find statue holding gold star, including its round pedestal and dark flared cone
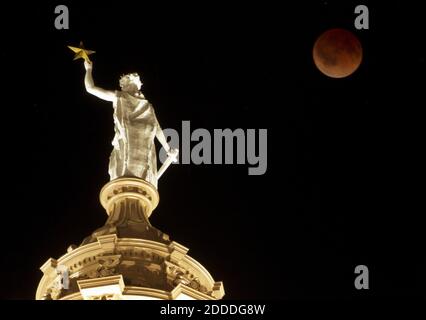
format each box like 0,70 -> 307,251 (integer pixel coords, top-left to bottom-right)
68,43 -> 179,245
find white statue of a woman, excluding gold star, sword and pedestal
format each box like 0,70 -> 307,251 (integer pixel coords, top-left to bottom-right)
84,60 -> 178,187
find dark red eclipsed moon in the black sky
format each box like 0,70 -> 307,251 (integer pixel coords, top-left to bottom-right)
313,29 -> 362,78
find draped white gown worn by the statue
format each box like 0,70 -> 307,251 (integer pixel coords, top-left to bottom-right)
109,91 -> 159,187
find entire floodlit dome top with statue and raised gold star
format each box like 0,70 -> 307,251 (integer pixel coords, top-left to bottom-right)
36,52 -> 224,300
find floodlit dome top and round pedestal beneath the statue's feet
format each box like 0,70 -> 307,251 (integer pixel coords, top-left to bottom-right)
36,178 -> 224,300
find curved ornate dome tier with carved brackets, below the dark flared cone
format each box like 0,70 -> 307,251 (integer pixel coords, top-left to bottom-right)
37,235 -> 224,299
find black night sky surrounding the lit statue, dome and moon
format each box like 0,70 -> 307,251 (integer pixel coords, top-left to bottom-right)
0,1 -> 426,299
